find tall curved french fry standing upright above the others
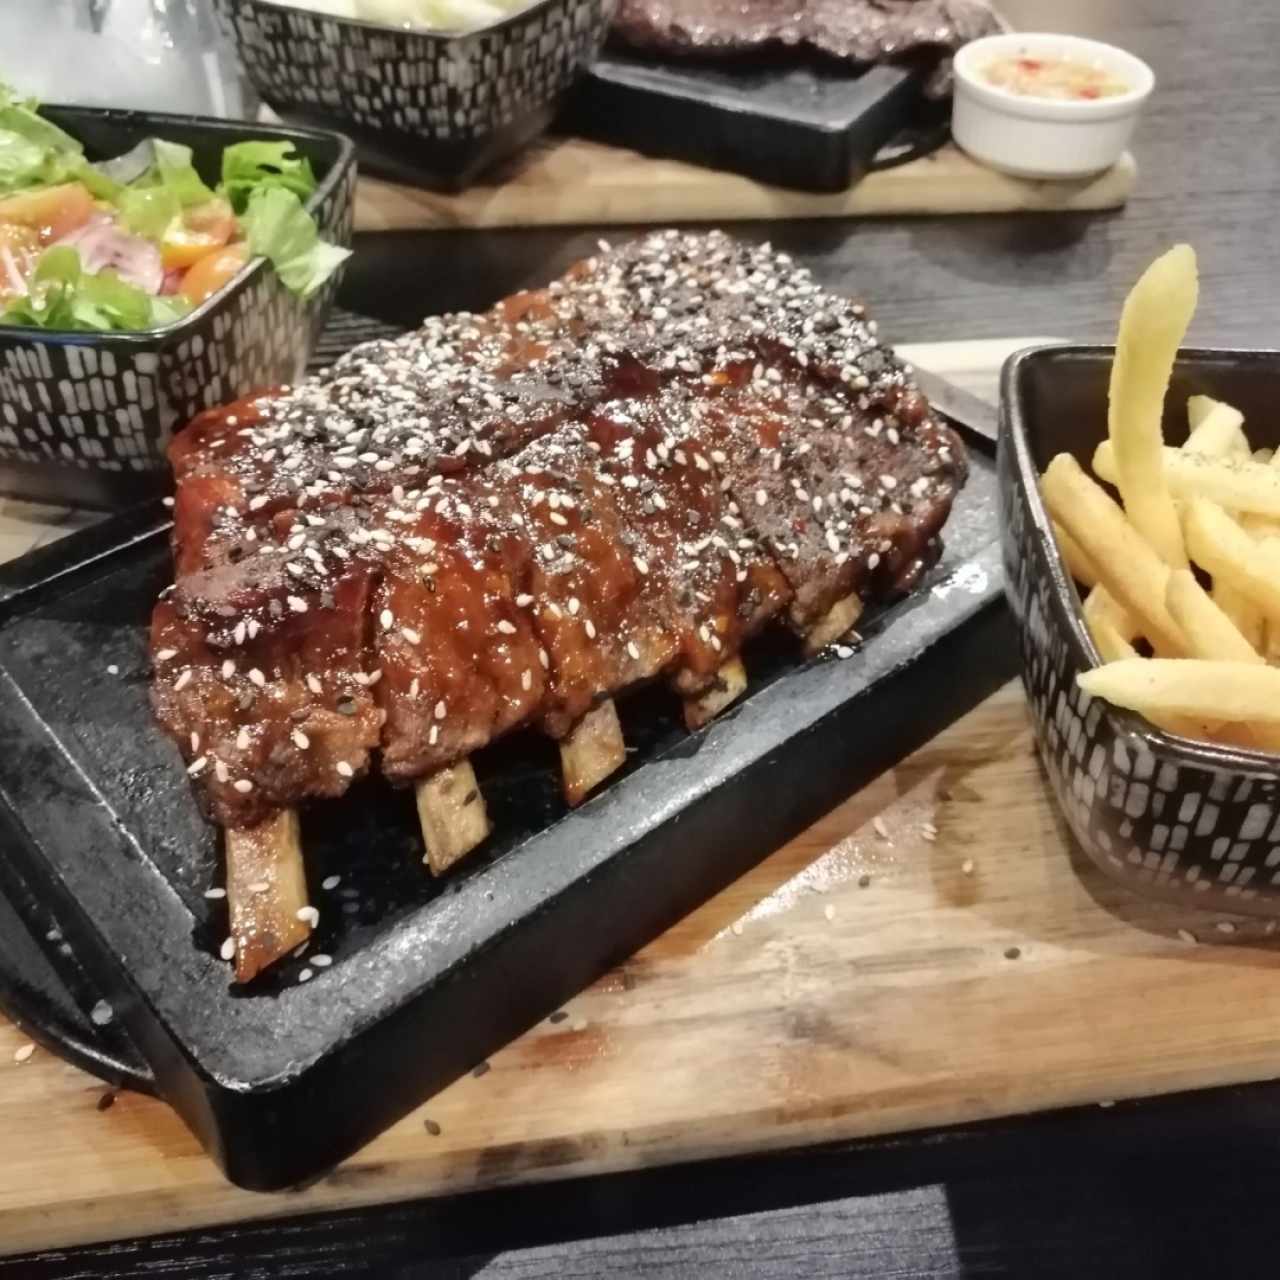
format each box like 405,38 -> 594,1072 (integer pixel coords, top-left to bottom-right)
1107,244 -> 1198,568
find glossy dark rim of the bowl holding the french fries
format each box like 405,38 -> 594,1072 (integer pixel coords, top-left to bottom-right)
1000,343 -> 1280,777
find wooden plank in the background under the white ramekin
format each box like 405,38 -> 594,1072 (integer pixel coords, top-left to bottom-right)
356,138 -> 1138,232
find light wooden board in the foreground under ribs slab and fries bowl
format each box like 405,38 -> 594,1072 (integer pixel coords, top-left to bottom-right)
10,343 -> 1280,1253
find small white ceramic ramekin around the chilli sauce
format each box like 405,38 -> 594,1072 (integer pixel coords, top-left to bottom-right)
951,32 -> 1156,178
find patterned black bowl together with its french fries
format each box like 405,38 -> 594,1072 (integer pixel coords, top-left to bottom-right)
1000,246 -> 1280,932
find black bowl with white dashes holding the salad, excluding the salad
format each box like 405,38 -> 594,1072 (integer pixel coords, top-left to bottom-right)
0,106 -> 356,507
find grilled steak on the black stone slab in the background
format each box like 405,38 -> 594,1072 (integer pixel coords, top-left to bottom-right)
613,0 -> 1001,63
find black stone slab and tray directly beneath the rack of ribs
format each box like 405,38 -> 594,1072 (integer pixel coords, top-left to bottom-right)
0,327 -> 1014,1189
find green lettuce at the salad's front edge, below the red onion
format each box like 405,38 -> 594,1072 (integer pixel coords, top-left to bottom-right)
0,244 -> 189,332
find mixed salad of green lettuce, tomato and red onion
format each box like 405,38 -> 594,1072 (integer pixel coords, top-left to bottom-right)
0,84 -> 349,330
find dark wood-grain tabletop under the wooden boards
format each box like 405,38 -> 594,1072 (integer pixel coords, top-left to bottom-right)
12,0 -> 1280,1280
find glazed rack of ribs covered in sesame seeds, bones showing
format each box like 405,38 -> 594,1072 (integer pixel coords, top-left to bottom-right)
152,232 -> 966,980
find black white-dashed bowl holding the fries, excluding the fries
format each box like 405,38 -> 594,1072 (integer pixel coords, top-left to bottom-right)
998,346 -> 1280,933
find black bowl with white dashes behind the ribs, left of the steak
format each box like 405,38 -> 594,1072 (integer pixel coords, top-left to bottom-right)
218,0 -> 617,189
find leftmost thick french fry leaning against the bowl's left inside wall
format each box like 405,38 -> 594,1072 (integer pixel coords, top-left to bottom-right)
1041,453 -> 1184,657
